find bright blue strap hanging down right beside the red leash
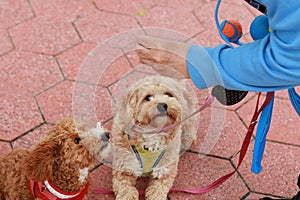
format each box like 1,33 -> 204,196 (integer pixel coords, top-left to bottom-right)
251,92 -> 274,174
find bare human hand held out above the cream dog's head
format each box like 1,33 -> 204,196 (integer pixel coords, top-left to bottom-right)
137,36 -> 191,78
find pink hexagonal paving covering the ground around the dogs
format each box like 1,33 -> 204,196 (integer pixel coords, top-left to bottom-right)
0,0 -> 300,200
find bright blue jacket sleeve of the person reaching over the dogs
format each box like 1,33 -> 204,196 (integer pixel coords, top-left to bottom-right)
187,0 -> 300,91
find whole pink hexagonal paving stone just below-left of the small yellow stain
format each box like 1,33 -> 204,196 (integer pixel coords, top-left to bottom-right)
75,12 -> 139,42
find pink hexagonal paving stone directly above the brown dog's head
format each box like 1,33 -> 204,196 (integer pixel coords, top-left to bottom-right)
37,81 -> 112,126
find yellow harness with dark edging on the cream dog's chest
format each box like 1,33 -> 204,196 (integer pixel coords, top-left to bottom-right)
131,145 -> 165,174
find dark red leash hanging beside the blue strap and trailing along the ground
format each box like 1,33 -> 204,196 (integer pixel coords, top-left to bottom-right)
93,92 -> 274,195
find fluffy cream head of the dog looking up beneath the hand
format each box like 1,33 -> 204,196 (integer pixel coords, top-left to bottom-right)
116,76 -> 195,142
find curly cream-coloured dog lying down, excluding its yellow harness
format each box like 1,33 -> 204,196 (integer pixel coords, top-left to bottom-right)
112,76 -> 197,200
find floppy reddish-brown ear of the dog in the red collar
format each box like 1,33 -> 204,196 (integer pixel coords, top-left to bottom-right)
23,138 -> 58,181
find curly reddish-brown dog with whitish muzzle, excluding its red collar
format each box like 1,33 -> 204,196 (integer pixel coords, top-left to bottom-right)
0,118 -> 110,200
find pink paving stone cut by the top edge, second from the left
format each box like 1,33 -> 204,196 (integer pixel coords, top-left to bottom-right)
31,0 -> 97,22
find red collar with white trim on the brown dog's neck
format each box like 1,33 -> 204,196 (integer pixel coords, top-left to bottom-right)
29,180 -> 89,200
